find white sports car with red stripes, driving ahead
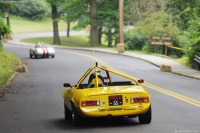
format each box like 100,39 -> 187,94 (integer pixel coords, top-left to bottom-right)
29,42 -> 55,58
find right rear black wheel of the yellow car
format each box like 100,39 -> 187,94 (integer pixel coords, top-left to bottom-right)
138,106 -> 151,124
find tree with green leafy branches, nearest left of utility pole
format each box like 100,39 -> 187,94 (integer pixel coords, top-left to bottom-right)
61,0 -> 98,47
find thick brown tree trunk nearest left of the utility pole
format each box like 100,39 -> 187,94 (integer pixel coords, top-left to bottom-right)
90,0 -> 99,47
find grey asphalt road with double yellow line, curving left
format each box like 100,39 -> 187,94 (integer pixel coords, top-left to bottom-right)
0,44 -> 200,133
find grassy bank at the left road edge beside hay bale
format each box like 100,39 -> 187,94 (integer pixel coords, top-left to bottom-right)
0,50 -> 19,88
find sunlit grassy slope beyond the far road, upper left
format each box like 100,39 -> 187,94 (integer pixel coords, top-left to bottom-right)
10,16 -> 75,34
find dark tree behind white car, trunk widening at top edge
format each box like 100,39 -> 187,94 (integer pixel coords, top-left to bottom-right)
47,0 -> 62,44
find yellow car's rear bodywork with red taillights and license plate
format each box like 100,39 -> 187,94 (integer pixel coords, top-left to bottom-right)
76,86 -> 151,123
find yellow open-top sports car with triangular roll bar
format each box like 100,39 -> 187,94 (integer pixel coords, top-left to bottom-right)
62,63 -> 151,125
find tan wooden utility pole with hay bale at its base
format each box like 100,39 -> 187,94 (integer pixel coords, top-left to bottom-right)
117,0 -> 125,53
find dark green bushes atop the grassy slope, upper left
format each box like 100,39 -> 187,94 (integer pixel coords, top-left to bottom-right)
11,0 -> 50,20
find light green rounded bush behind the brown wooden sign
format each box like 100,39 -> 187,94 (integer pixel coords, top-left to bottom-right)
138,11 -> 180,55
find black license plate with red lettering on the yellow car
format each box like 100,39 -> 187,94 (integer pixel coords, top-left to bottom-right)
108,95 -> 123,106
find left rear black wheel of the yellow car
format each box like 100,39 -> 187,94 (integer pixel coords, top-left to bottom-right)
72,105 -> 81,126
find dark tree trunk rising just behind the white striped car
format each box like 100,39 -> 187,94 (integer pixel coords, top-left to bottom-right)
51,3 -> 60,44
